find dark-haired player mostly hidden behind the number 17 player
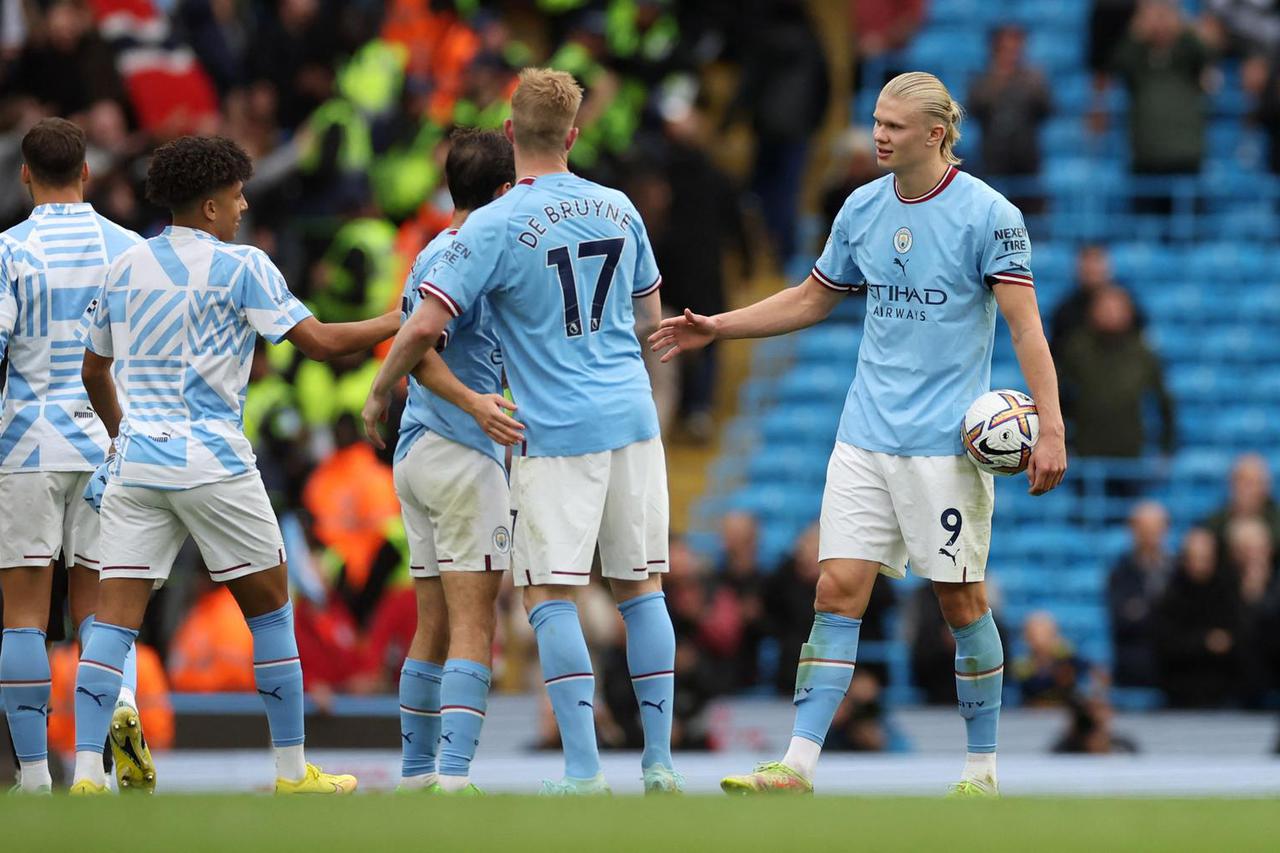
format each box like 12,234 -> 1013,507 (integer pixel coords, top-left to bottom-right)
370,131 -> 524,794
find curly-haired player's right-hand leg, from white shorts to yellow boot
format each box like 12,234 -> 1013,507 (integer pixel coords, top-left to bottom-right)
177,471 -> 356,794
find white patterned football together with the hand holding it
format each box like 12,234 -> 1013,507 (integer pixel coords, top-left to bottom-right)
960,389 -> 1066,494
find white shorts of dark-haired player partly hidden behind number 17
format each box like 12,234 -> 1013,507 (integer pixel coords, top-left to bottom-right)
396,433 -> 511,578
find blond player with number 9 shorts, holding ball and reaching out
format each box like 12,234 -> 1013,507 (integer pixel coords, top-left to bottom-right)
650,72 -> 1066,795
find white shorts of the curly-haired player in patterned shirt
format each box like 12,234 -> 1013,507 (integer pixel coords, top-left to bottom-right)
101,470 -> 284,587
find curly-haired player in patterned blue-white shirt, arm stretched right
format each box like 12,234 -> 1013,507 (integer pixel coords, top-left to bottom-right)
72,136 -> 399,794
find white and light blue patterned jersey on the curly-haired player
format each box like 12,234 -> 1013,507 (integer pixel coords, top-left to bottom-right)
78,227 -> 311,489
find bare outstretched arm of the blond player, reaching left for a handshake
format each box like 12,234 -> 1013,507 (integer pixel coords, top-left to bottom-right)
649,275 -> 847,361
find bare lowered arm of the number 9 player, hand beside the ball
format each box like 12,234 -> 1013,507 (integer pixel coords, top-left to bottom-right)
995,283 -> 1066,494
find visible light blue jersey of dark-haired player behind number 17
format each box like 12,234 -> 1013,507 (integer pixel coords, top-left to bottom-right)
396,228 -> 504,465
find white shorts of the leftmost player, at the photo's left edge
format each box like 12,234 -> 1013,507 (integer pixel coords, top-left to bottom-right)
0,471 -> 99,571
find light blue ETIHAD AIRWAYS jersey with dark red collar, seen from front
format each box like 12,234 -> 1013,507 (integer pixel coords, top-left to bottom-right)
813,167 -> 1033,456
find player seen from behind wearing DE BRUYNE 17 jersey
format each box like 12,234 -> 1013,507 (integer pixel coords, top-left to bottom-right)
365,68 -> 682,794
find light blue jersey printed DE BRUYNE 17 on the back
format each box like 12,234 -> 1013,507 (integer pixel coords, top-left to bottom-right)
422,172 -> 662,456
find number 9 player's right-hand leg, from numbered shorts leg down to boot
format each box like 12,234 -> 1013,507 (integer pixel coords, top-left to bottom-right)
884,456 -> 1005,795
